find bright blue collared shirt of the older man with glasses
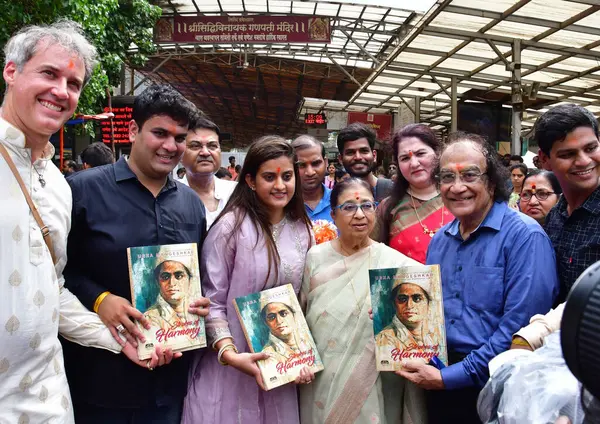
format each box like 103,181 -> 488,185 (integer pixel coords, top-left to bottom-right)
427,202 -> 558,389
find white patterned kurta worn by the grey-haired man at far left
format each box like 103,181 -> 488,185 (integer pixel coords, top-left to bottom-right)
0,119 -> 121,424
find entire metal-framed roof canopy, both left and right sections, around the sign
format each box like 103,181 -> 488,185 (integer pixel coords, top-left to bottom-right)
135,0 -> 600,144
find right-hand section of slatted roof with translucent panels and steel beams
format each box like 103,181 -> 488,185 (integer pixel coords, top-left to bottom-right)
343,0 -> 600,132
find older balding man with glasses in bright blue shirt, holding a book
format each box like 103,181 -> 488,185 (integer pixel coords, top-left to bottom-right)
399,133 -> 558,424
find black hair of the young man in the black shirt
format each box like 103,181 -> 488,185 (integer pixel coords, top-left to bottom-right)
132,84 -> 198,129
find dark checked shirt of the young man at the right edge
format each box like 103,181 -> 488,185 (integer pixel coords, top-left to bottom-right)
544,187 -> 600,302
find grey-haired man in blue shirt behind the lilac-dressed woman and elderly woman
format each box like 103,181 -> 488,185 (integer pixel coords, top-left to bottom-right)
292,135 -> 333,222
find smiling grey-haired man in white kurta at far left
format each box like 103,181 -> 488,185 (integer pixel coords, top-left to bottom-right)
0,22 -> 126,424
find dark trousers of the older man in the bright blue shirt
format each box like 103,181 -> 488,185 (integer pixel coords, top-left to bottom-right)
427,387 -> 481,424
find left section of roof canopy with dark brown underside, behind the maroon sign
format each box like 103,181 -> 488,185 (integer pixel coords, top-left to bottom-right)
131,0 -> 422,143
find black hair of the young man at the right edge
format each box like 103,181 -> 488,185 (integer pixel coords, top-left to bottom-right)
534,103 -> 598,157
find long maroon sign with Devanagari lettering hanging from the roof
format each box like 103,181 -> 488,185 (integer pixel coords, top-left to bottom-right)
154,15 -> 331,44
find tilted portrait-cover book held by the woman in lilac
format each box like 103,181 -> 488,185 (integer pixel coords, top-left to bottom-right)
233,284 -> 323,390
